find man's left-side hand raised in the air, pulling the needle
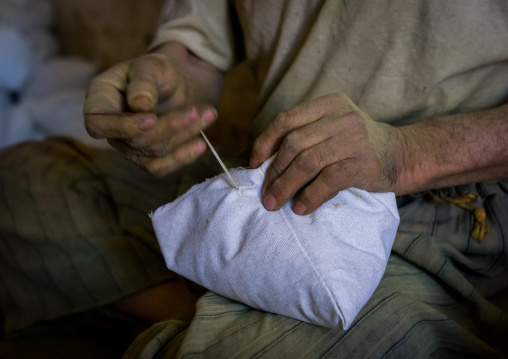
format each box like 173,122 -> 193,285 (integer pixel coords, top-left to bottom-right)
84,43 -> 223,176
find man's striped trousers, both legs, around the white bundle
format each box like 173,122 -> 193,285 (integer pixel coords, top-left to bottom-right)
0,139 -> 508,359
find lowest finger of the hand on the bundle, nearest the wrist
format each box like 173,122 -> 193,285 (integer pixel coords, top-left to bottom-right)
293,159 -> 360,215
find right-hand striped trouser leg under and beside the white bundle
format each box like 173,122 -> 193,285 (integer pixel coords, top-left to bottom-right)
125,185 -> 508,358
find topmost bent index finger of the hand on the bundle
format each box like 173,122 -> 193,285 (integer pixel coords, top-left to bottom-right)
250,101 -> 323,168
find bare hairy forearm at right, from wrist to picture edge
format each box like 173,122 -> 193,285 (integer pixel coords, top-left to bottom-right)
396,105 -> 508,195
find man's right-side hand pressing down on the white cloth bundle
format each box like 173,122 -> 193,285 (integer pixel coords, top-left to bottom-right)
250,94 -> 404,215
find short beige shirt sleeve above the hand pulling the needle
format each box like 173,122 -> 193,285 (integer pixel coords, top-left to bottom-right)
150,0 -> 236,71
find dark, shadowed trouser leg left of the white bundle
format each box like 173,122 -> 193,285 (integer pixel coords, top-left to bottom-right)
0,138 -> 189,332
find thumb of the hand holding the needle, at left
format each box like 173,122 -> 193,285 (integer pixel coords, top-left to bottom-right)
127,54 -> 177,112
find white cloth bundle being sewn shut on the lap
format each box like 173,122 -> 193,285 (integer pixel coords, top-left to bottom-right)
152,160 -> 399,329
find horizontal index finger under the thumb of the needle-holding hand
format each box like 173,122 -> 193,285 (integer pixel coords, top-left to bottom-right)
84,113 -> 157,139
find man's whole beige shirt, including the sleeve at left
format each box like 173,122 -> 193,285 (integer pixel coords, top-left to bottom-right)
154,0 -> 508,134
